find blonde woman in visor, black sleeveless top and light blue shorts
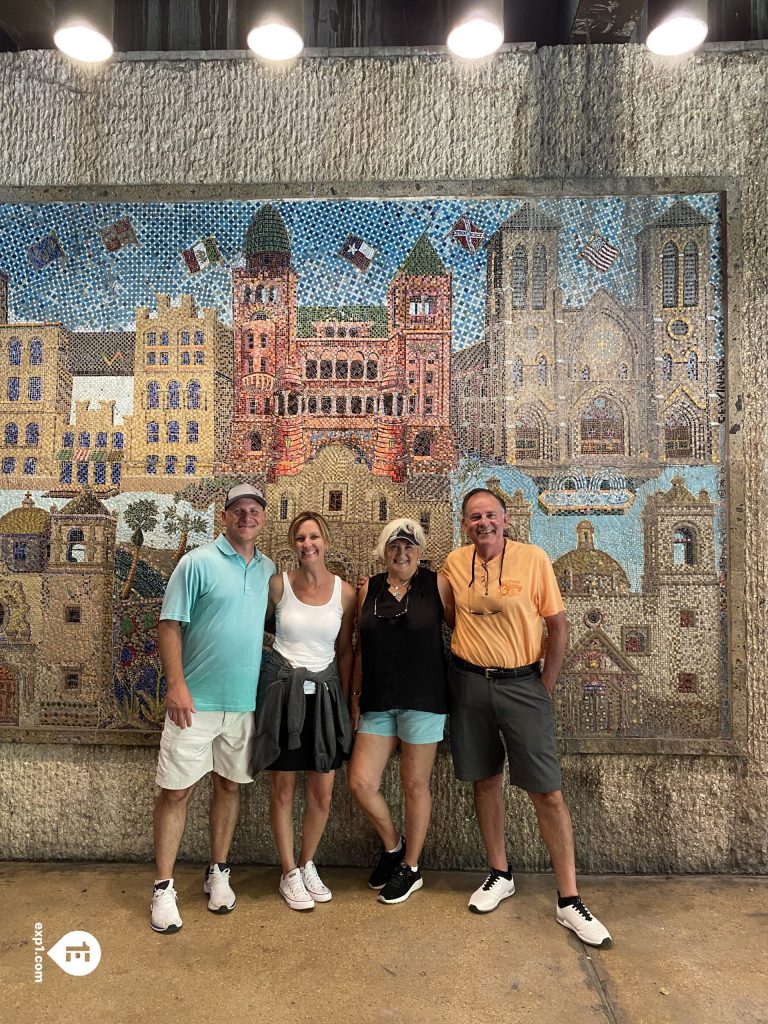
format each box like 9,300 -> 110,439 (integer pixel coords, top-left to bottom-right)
349,519 -> 453,903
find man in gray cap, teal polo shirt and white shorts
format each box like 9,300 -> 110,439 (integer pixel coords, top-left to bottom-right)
152,483 -> 275,933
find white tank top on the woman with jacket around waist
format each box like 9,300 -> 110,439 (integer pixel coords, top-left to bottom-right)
274,572 -> 343,693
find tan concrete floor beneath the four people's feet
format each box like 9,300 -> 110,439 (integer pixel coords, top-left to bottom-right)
0,862 -> 768,1024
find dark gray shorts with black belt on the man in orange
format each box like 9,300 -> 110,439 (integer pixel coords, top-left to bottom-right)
449,665 -> 562,793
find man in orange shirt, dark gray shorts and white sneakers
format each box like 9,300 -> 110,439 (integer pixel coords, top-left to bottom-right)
442,487 -> 610,946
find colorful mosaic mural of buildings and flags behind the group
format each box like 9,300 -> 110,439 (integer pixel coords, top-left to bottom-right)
0,194 -> 730,739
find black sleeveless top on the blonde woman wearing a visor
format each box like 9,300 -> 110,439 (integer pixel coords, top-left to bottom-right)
359,568 -> 447,714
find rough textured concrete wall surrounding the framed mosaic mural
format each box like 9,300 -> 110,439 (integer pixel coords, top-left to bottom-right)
0,46 -> 768,871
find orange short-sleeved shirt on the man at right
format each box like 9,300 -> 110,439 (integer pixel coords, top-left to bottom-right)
442,541 -> 564,669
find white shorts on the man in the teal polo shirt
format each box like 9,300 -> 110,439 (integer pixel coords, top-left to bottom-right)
155,711 -> 255,790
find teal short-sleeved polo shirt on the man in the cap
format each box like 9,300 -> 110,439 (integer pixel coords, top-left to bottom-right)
160,534 -> 275,711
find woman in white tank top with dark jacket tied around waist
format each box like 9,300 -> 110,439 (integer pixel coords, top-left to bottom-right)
256,512 -> 355,910
